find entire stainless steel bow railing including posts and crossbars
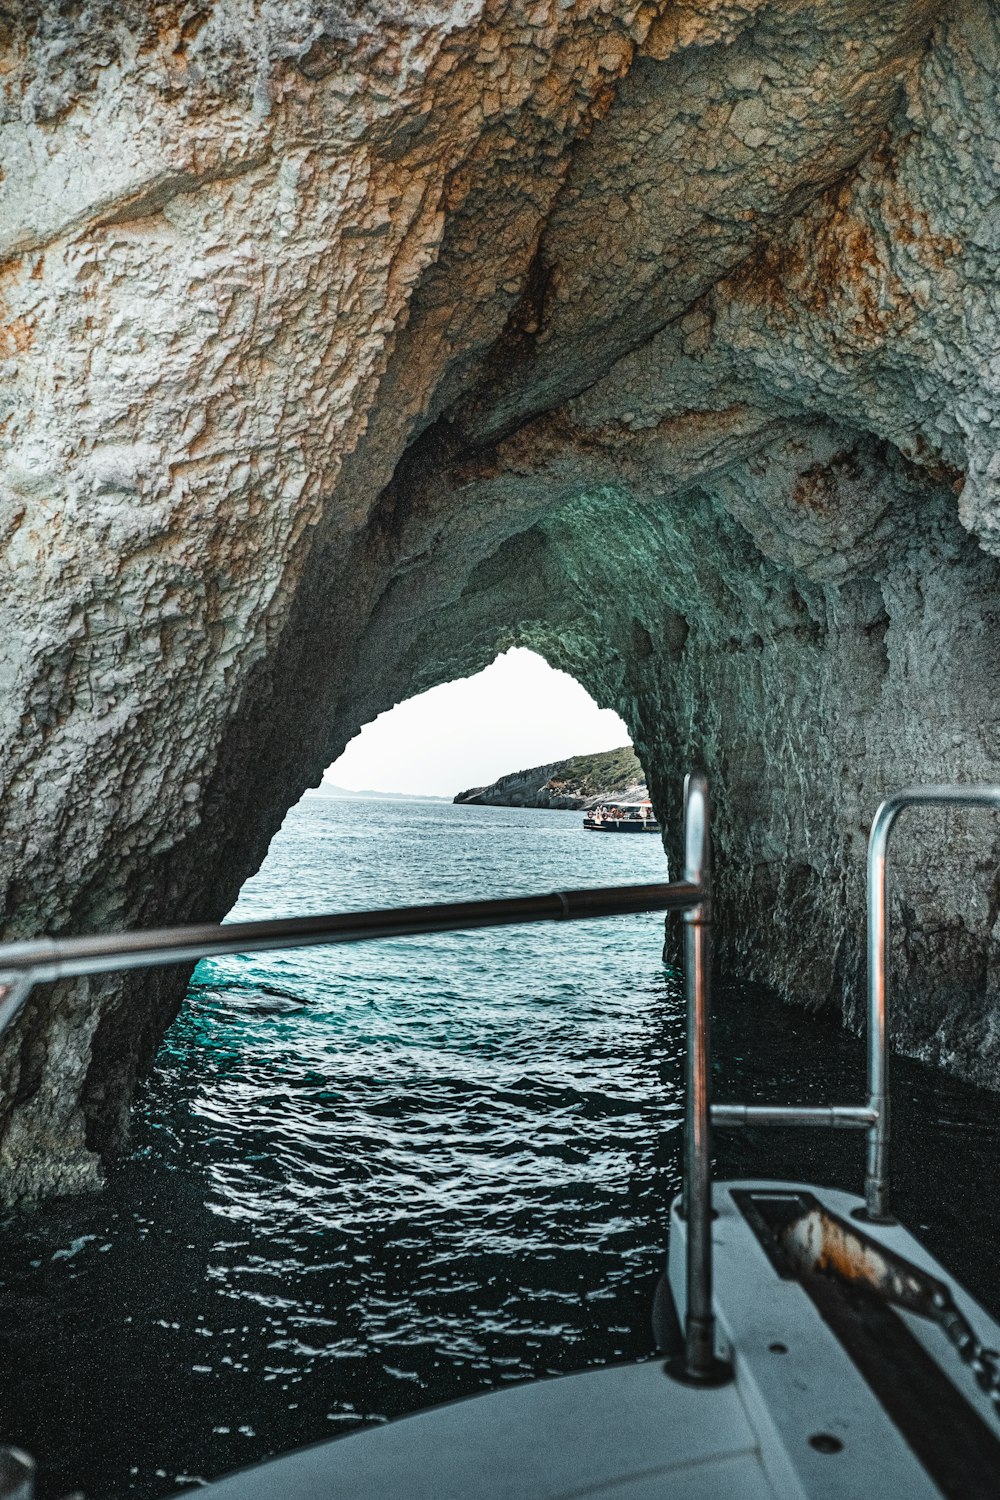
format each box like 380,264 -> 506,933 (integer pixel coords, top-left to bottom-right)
0,776 -> 1000,1385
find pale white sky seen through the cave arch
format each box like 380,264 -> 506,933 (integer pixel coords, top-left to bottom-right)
324,647 -> 628,797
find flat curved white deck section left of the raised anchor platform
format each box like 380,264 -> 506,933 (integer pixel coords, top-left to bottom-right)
201,1361 -> 775,1500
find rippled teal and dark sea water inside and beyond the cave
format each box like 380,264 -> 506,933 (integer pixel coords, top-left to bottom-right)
0,798 -> 1000,1500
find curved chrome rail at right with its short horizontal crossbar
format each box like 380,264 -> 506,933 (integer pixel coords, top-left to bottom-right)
711,786 -> 1000,1223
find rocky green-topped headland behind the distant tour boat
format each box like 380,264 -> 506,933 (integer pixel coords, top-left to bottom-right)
454,746 -> 649,809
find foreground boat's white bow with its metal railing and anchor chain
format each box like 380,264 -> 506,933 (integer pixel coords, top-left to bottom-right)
0,777 -> 1000,1500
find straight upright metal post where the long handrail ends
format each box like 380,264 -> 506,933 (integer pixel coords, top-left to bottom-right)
667,776 -> 732,1385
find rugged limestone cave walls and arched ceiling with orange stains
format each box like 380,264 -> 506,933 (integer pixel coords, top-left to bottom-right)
0,0 -> 1000,1196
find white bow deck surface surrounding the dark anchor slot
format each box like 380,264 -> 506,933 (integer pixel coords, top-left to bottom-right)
202,1182 -> 1000,1500
